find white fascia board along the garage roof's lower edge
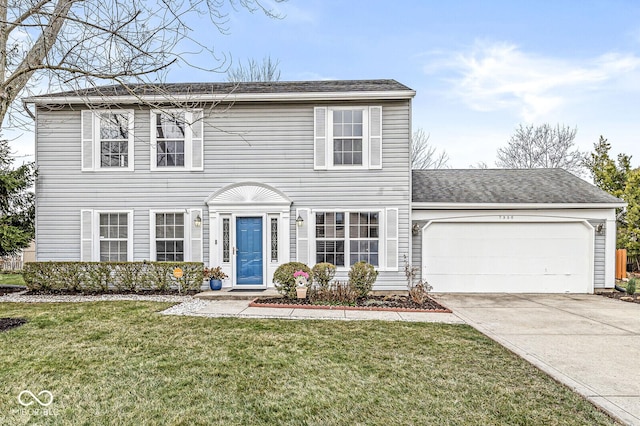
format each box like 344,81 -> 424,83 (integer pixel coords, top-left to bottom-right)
411,202 -> 627,210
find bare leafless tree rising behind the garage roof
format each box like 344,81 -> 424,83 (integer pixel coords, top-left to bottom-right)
496,124 -> 586,176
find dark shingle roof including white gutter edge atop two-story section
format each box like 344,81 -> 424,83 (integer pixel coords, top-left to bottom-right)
25,80 -> 415,103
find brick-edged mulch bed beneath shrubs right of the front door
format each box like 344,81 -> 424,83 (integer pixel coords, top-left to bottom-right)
249,295 -> 451,313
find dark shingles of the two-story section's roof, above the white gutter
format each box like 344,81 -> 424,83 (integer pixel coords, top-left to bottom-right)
33,80 -> 412,99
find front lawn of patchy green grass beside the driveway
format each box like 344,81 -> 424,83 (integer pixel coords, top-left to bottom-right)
0,302 -> 613,426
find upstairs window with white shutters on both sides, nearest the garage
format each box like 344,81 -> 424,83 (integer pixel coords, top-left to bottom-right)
314,106 -> 382,170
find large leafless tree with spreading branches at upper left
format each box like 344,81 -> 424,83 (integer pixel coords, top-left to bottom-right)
0,0 -> 283,130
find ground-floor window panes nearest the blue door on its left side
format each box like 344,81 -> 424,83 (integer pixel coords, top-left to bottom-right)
155,213 -> 185,262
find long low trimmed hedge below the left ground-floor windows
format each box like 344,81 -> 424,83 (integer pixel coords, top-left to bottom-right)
23,262 -> 204,293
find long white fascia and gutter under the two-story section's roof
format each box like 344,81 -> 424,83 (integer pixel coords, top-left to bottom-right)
24,90 -> 416,105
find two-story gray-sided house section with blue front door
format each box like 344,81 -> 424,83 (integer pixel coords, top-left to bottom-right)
27,80 -> 415,289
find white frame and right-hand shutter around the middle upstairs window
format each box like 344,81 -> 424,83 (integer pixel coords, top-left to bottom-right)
149,108 -> 204,172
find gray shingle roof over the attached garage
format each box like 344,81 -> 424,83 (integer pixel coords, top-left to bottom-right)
412,169 -> 623,204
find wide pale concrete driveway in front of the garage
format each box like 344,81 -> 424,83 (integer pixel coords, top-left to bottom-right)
434,294 -> 640,425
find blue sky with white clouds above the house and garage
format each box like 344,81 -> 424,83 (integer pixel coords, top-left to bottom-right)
8,0 -> 640,168
